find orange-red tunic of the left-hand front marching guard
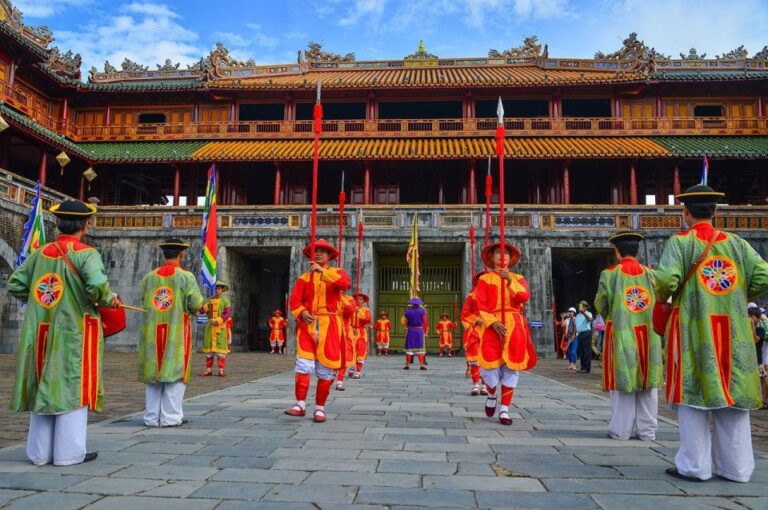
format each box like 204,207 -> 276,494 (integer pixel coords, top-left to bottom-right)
288,267 -> 350,370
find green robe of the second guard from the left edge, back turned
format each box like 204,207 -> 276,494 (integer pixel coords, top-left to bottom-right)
139,263 -> 203,384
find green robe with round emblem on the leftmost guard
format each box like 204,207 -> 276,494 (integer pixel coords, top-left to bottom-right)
8,235 -> 114,414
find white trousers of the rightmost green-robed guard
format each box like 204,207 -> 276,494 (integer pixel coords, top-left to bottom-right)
675,405 -> 755,482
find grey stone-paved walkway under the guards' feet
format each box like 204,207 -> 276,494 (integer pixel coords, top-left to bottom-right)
0,356 -> 768,510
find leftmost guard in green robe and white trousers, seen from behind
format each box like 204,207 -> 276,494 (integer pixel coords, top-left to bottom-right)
8,200 -> 121,466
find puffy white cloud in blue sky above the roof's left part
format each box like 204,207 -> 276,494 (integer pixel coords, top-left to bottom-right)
56,2 -> 210,74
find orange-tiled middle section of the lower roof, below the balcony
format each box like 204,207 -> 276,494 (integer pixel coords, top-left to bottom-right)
192,137 -> 670,161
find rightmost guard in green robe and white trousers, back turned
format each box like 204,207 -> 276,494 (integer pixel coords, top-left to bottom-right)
655,185 -> 768,482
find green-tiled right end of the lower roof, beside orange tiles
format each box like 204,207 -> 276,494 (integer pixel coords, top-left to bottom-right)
651,136 -> 768,159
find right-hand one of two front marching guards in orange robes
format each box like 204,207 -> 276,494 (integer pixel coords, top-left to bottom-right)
475,243 -> 536,425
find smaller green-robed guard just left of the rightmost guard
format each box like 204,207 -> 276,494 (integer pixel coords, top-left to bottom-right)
595,232 -> 662,441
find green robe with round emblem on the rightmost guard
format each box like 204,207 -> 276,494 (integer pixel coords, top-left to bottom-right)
654,222 -> 768,409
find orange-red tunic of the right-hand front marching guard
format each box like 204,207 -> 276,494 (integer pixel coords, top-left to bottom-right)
475,271 -> 536,370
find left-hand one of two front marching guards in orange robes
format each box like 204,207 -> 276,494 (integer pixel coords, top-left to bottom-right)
285,239 -> 350,423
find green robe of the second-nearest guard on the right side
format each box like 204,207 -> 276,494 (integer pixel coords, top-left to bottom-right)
595,257 -> 662,393
